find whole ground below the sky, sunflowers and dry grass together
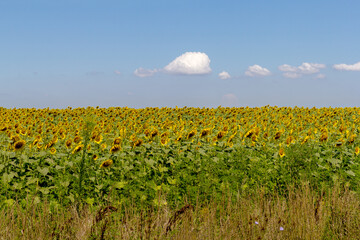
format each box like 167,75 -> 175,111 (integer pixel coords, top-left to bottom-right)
0,106 -> 360,239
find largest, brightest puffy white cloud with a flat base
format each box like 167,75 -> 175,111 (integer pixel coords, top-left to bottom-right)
164,52 -> 211,75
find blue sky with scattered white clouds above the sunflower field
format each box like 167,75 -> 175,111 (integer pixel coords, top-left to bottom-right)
0,0 -> 360,108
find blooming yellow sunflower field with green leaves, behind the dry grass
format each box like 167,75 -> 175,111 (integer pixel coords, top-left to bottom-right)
0,106 -> 360,209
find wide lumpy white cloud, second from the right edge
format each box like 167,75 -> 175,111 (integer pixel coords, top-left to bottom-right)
278,63 -> 326,78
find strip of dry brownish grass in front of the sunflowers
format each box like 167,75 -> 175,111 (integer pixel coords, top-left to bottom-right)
0,187 -> 360,240
